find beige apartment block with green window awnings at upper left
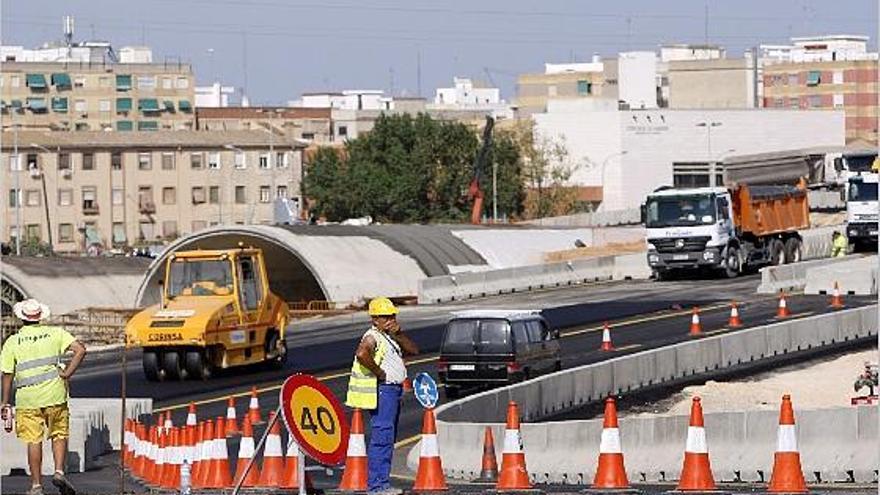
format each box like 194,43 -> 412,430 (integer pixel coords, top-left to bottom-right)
0,62 -> 195,131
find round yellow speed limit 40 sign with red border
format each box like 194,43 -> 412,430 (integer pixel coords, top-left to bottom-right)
280,375 -> 348,466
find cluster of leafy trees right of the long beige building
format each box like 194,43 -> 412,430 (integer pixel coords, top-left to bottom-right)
303,114 -> 577,223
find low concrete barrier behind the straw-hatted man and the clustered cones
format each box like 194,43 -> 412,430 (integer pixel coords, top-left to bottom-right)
0,398 -> 153,476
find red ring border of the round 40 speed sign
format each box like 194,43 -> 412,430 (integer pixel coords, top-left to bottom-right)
279,373 -> 349,466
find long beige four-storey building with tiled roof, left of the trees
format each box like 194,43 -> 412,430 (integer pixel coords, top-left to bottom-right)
0,131 -> 305,252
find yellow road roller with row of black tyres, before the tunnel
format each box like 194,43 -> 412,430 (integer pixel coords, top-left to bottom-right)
125,247 -> 289,381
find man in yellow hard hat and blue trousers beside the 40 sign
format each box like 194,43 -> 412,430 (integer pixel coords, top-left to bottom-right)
345,297 -> 419,495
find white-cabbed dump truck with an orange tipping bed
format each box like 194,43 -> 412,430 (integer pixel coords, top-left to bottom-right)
642,180 -> 810,280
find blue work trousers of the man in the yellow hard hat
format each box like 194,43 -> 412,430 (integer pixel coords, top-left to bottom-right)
367,384 -> 403,492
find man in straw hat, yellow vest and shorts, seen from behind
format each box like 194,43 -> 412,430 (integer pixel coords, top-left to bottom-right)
0,299 -> 86,495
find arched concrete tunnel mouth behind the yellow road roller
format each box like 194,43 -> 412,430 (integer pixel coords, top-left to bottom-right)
138,233 -> 327,307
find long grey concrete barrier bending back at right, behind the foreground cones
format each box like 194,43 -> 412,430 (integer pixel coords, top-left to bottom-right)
422,306 -> 880,483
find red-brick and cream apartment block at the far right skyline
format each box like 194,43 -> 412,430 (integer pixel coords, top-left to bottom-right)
763,60 -> 878,143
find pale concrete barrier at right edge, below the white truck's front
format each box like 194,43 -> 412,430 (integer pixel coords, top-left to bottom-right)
804,255 -> 877,295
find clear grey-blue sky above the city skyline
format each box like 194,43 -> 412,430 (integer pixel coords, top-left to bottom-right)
0,0 -> 878,105
